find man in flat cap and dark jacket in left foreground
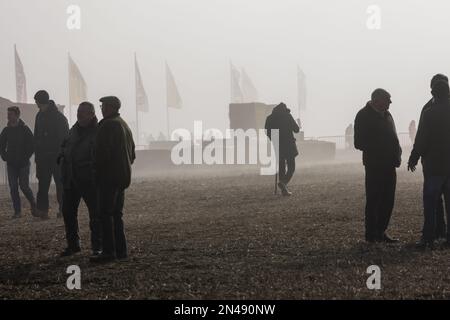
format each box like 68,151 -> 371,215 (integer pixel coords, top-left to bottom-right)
91,97 -> 136,263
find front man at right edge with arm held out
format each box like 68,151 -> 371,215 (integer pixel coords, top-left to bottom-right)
408,80 -> 450,248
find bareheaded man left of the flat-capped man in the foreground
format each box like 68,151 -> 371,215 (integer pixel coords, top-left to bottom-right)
58,102 -> 102,257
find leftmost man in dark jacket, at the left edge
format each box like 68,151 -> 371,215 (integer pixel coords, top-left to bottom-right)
0,107 -> 36,219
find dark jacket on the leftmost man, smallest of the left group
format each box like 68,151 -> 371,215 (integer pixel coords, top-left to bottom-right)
0,119 -> 34,168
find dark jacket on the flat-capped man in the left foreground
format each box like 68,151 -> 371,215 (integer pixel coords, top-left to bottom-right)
95,114 -> 136,189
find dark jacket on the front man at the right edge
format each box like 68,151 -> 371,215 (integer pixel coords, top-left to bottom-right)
409,100 -> 450,176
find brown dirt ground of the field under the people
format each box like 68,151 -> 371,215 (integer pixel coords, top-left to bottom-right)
0,163 -> 450,299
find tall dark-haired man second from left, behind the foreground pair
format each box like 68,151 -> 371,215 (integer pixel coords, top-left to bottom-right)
34,90 -> 69,219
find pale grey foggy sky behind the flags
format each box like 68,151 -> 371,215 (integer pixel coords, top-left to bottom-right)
0,0 -> 450,141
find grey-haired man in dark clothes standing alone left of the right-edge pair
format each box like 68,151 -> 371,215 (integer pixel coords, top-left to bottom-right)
354,89 -> 402,243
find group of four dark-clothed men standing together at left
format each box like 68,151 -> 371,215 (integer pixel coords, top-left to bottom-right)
0,90 -> 136,263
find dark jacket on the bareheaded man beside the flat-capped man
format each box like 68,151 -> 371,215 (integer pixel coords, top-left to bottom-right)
59,118 -> 98,189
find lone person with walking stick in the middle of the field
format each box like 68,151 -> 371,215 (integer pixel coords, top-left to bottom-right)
265,103 -> 300,196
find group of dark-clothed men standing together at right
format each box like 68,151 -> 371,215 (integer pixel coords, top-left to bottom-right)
354,74 -> 450,248
